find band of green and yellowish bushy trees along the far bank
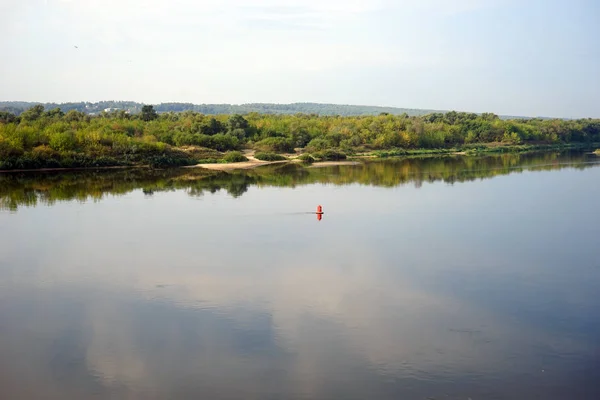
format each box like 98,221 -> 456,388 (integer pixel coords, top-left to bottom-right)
0,105 -> 600,169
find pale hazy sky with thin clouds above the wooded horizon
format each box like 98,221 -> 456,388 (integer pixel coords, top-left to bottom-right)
0,0 -> 600,117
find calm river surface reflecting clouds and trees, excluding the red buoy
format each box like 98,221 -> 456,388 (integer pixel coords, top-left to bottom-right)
0,154 -> 600,400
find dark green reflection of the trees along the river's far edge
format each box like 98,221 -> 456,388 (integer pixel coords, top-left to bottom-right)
0,153 -> 597,210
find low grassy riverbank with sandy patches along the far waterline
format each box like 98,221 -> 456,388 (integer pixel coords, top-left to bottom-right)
0,143 -> 600,172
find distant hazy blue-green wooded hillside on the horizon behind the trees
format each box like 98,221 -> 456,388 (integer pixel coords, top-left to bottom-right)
0,101 -> 435,116
